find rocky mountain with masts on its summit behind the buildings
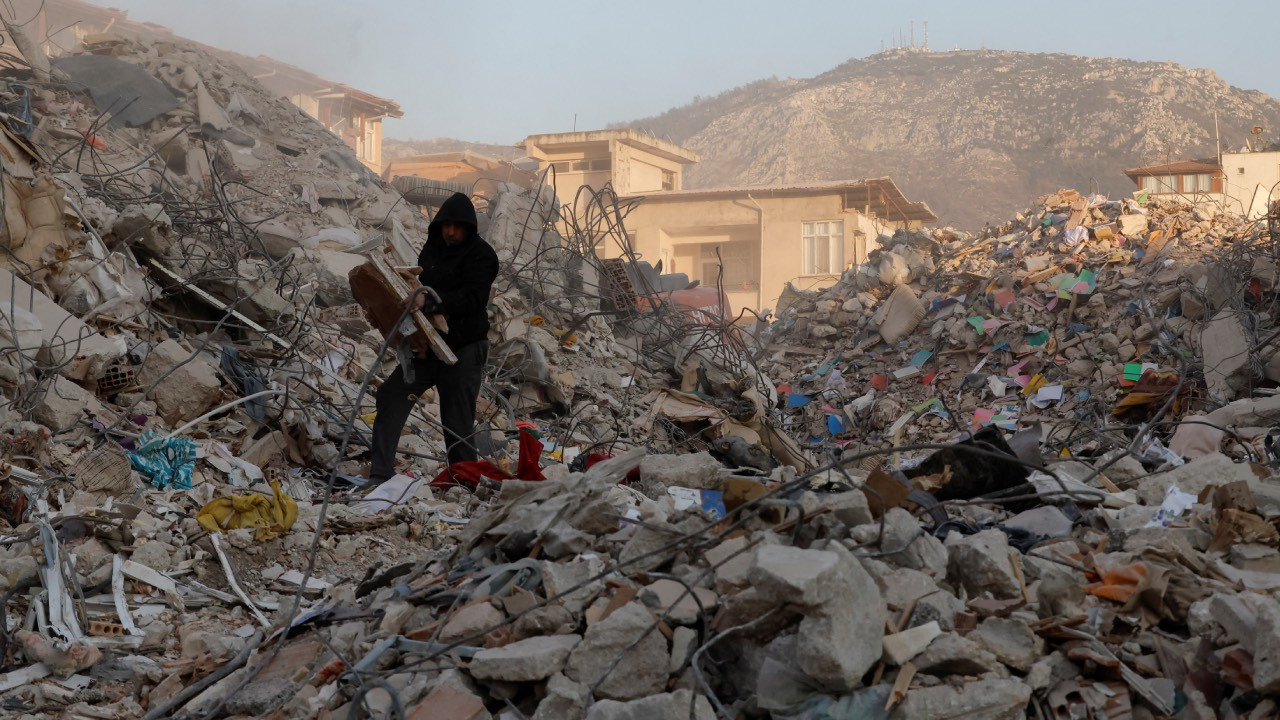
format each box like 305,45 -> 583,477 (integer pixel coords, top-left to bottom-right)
623,50 -> 1280,229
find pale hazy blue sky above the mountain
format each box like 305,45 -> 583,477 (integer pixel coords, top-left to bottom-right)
101,0 -> 1280,145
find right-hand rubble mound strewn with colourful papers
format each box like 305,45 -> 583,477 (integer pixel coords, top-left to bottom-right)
763,191 -> 1280,455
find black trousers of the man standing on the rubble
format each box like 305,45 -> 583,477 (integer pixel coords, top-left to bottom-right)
369,340 -> 489,480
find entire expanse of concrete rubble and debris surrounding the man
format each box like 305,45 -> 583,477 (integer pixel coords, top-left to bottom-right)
0,19 -> 1280,720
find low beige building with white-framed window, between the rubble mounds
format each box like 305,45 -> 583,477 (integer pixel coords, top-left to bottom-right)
614,178 -> 937,313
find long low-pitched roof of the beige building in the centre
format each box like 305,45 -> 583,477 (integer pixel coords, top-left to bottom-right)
632,177 -> 938,223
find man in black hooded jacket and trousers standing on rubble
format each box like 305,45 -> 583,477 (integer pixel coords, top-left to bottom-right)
369,192 -> 498,482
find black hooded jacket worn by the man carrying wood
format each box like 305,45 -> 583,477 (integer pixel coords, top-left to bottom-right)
417,192 -> 498,350
